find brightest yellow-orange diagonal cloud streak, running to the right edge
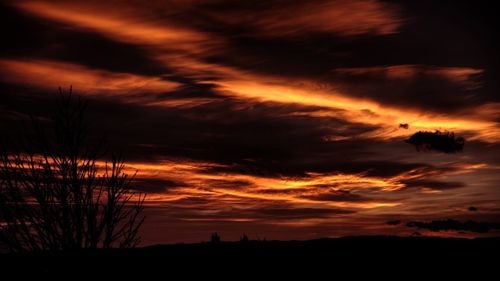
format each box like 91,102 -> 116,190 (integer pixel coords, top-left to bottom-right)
214,73 -> 500,142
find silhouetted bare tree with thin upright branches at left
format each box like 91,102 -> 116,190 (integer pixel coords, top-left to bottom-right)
0,89 -> 145,251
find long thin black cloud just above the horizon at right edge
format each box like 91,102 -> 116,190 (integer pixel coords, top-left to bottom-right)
406,219 -> 500,233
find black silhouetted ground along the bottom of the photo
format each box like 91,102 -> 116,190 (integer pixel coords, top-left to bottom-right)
0,236 -> 500,280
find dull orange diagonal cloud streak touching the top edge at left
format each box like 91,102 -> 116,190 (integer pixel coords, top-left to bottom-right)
14,1 -> 217,53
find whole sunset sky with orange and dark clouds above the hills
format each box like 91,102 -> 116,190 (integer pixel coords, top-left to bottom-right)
0,0 -> 500,245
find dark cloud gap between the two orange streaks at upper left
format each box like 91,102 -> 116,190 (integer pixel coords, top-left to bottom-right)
0,2 -> 171,76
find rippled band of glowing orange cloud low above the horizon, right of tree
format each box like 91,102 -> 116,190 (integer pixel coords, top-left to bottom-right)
116,155 -> 484,226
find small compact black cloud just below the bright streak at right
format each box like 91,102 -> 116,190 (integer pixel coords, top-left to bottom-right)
406,131 -> 465,153
